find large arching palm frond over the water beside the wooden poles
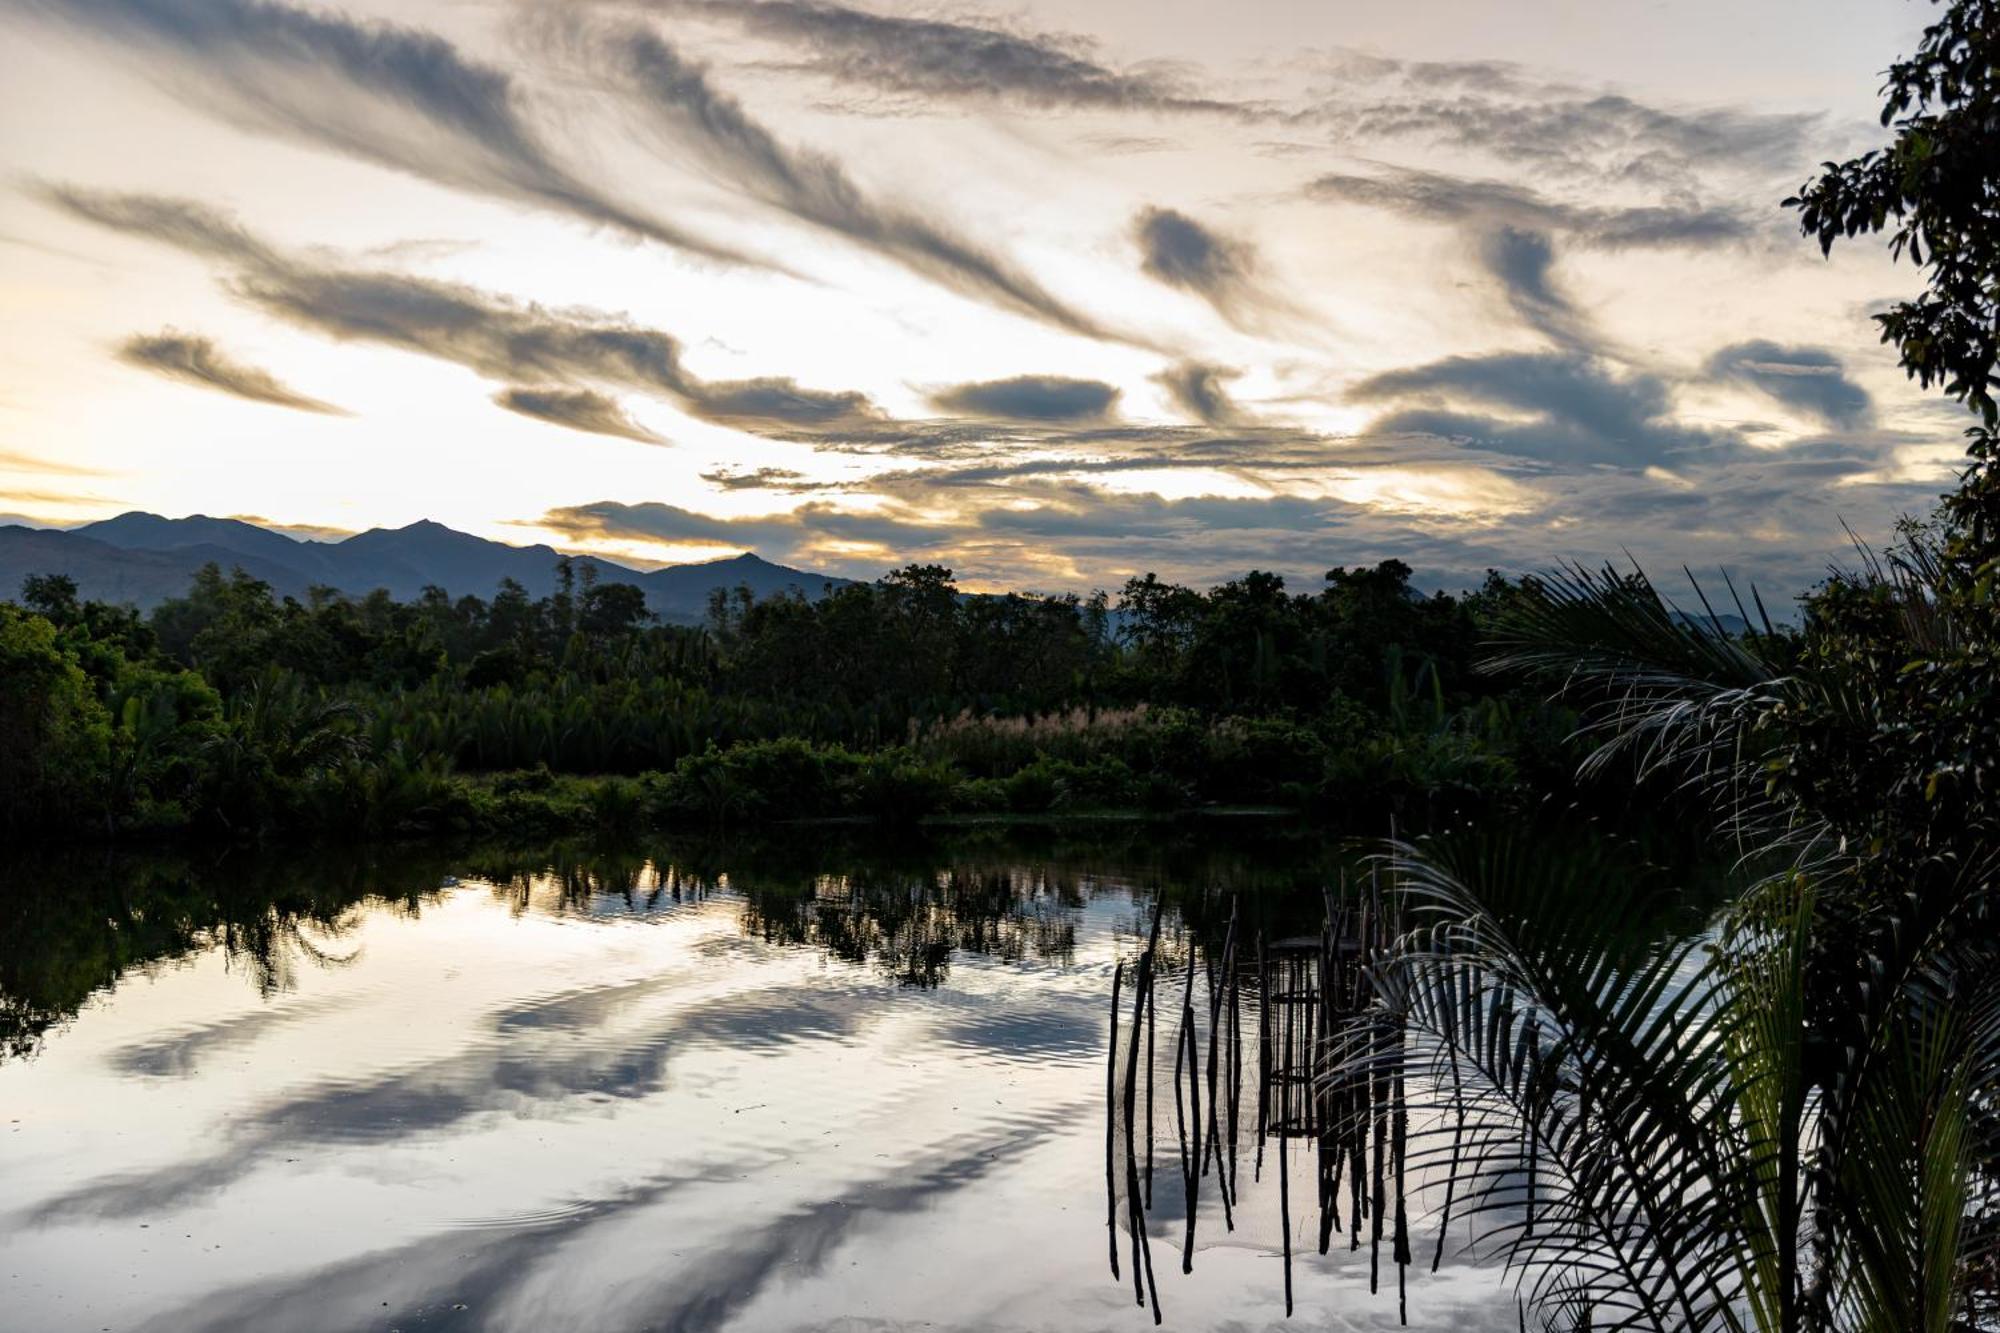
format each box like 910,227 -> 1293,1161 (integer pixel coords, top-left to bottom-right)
1334,827 -> 1770,1329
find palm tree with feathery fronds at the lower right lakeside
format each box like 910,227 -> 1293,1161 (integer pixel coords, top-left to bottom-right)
1330,548 -> 2000,1333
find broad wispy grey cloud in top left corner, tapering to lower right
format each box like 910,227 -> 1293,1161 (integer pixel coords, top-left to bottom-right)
24,0 -> 758,262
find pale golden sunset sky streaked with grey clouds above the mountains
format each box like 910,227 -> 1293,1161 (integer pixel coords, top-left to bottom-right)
0,0 -> 1968,596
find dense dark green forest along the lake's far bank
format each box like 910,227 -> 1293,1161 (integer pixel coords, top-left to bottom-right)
0,544 -> 1608,839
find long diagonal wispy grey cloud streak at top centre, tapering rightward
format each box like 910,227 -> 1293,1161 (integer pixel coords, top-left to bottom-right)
570,24 -> 1110,338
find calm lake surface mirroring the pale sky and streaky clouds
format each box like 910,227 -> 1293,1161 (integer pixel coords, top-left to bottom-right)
0,827 -> 1516,1333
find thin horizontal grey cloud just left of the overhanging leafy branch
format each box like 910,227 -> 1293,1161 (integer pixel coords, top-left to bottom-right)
1306,166 -> 1768,250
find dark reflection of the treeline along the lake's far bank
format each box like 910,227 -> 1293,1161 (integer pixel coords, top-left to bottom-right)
0,827 -> 1338,1059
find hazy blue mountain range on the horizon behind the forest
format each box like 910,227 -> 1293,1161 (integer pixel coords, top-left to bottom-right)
0,510 -> 850,622
